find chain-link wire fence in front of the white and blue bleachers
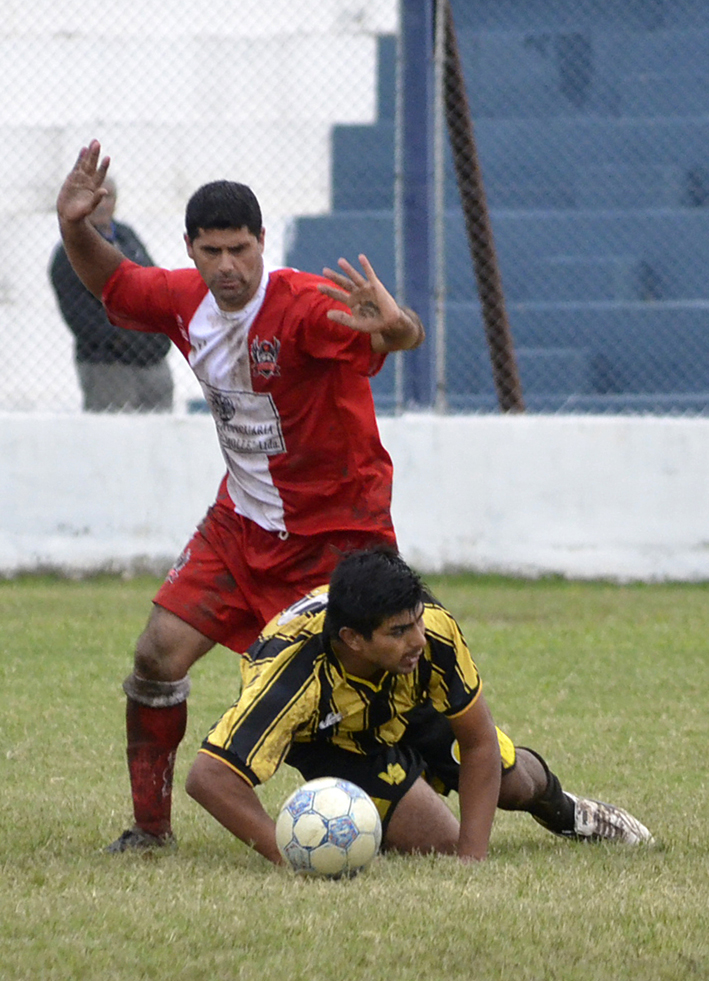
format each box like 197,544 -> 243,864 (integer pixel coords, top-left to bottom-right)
0,0 -> 709,414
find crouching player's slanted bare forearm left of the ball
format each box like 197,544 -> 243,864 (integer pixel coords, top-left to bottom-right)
186,753 -> 283,865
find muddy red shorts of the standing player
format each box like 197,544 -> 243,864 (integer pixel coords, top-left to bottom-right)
154,504 -> 396,653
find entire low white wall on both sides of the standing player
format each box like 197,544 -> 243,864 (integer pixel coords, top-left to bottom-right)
0,414 -> 709,581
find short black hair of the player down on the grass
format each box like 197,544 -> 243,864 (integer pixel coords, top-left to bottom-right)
323,547 -> 430,640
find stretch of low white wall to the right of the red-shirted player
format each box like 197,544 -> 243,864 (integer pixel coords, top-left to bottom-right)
382,416 -> 709,580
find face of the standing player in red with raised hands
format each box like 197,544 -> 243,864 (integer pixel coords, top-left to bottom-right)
185,228 -> 264,312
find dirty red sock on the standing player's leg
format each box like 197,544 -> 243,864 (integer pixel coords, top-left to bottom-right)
126,698 -> 187,835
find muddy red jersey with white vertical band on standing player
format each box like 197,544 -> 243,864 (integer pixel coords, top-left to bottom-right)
103,261 -> 392,535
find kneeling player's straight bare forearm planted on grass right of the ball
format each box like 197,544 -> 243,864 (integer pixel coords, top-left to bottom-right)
458,745 -> 501,861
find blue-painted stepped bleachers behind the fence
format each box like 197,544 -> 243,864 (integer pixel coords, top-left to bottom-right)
286,0 -> 709,413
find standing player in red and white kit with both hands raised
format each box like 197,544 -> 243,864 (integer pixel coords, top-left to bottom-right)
57,140 -> 424,852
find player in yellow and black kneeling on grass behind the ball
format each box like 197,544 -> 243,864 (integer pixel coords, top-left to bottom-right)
187,549 -> 651,864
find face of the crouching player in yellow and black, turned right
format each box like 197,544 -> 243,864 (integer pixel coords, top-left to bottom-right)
348,605 -> 426,678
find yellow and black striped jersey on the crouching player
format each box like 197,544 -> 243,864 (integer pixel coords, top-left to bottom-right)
202,586 -> 482,785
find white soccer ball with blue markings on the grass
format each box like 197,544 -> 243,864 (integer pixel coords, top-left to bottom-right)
276,777 -> 382,879
